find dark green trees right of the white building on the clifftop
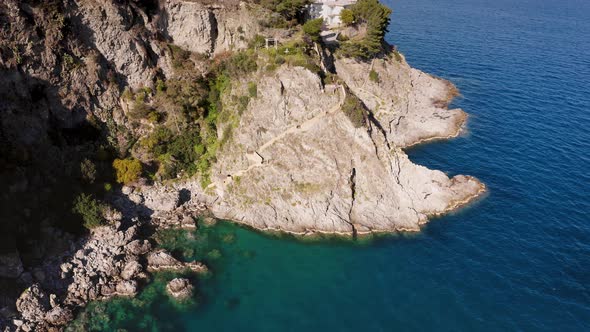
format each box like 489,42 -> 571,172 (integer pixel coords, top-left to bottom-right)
340,0 -> 391,60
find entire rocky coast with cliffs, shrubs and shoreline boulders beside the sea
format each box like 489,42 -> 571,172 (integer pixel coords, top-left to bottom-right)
0,0 -> 485,331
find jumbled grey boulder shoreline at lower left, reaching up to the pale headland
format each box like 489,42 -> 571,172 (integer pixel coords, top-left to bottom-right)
4,188 -> 208,331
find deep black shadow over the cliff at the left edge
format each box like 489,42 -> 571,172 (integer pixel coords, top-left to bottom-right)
0,68 -> 152,318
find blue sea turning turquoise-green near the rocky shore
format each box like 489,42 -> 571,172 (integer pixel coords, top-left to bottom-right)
72,0 -> 590,331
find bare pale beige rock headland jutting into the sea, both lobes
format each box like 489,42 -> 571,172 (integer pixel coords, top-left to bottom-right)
197,59 -> 484,234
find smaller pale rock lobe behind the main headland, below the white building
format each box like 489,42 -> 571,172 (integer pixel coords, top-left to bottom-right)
335,53 -> 467,148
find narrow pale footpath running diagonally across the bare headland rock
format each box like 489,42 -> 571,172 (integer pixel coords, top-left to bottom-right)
213,85 -> 346,188
